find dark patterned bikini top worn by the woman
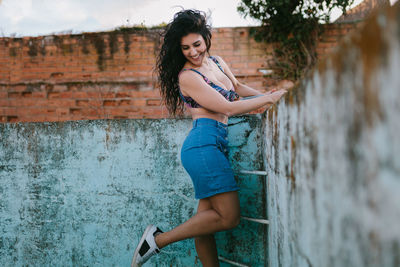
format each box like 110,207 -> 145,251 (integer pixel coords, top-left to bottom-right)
179,56 -> 239,108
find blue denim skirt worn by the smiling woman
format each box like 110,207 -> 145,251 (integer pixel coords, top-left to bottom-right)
181,118 -> 239,199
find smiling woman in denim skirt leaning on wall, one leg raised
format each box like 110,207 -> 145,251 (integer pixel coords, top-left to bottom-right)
132,10 -> 286,267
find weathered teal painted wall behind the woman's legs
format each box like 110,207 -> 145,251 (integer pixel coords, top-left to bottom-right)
0,116 -> 266,267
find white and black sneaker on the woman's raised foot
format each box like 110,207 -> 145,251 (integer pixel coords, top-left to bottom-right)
131,224 -> 163,267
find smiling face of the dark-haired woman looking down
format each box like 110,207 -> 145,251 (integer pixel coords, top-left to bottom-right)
181,33 -> 207,66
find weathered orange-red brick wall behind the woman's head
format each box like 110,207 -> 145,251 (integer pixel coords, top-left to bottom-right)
0,24 -> 360,122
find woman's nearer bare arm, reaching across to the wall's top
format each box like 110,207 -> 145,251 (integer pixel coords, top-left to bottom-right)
179,71 -> 287,116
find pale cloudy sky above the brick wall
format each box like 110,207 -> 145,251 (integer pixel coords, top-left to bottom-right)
0,0 -> 396,37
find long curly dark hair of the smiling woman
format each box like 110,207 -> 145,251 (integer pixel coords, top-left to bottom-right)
156,9 -> 212,116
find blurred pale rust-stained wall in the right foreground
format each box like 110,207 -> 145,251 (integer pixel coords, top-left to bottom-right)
264,3 -> 400,267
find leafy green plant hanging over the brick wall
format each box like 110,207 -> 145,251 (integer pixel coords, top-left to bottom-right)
237,0 -> 354,80
